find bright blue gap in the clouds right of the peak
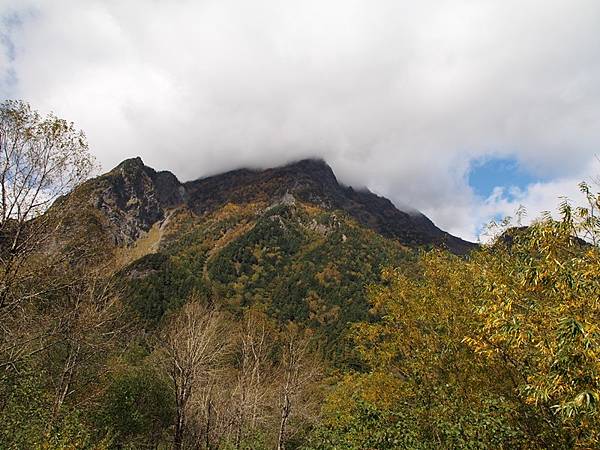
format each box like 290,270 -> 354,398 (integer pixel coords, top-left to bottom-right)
468,158 -> 540,198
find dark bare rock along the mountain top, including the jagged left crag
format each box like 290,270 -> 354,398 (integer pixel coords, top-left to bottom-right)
78,158 -> 475,254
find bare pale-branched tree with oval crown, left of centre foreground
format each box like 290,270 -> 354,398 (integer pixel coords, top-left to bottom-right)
160,298 -> 229,450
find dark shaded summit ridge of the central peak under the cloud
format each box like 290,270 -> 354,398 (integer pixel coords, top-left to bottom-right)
185,159 -> 475,254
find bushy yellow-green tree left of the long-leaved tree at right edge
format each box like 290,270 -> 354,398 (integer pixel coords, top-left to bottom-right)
309,250 -> 518,450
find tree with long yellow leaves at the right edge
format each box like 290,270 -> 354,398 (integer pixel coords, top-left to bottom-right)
465,191 -> 600,448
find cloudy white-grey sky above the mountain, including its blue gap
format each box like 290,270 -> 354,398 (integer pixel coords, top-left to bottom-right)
0,0 -> 600,240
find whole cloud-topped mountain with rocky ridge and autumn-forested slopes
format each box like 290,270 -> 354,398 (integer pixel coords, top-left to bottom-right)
59,158 -> 475,357
